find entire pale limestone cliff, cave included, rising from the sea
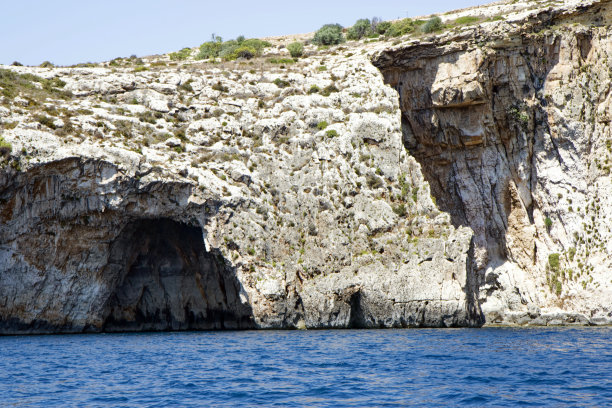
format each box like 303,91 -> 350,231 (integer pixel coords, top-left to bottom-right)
0,1 -> 612,333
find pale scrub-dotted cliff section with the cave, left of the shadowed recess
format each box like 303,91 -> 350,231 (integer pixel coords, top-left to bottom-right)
0,39 -> 482,333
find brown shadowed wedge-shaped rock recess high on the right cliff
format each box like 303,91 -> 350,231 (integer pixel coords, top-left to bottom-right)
373,28 -> 564,276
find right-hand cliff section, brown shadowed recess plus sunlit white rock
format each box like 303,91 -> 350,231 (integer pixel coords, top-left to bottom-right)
374,1 -> 612,324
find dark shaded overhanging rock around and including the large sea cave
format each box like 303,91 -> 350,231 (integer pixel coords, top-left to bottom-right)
0,158 -> 254,333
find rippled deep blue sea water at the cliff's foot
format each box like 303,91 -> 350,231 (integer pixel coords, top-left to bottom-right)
0,328 -> 612,407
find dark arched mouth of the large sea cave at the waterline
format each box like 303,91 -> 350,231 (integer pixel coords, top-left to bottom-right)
102,218 -> 254,332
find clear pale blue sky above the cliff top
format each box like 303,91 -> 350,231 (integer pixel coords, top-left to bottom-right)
0,0 -> 490,65
